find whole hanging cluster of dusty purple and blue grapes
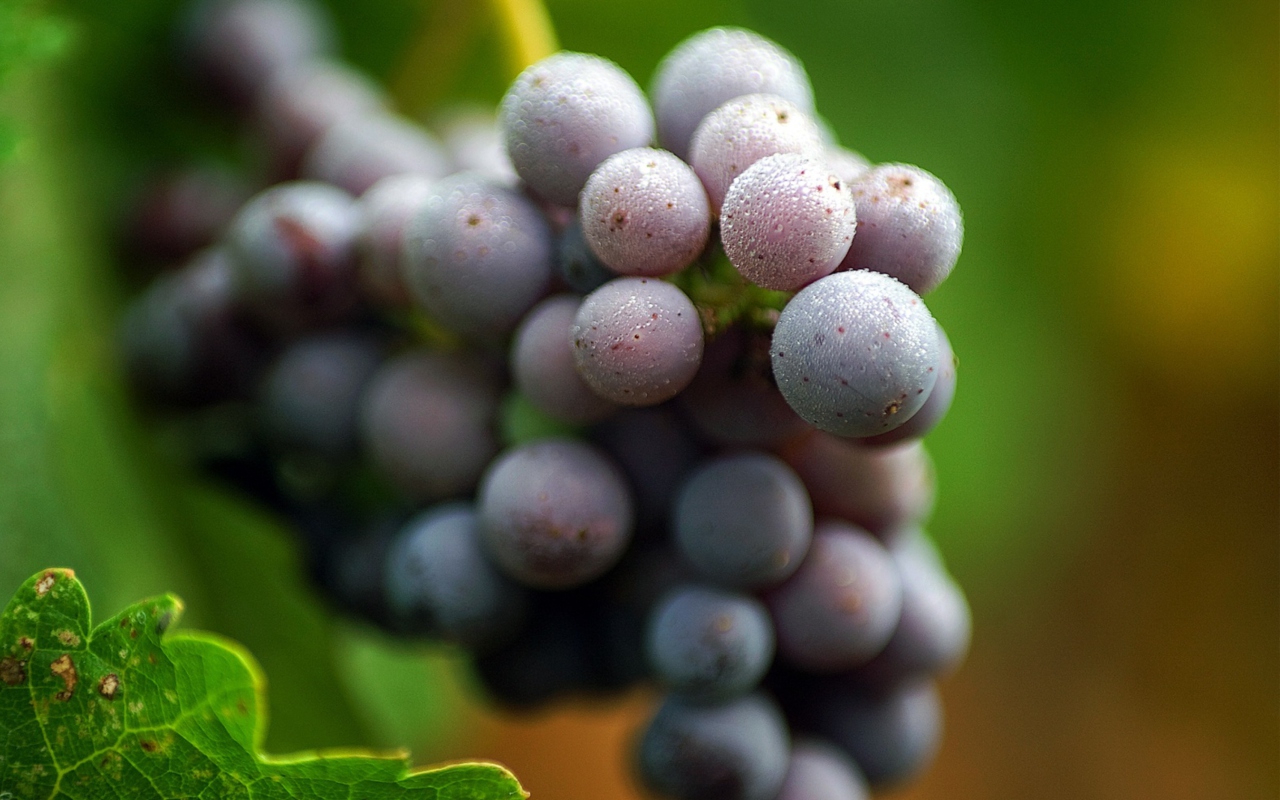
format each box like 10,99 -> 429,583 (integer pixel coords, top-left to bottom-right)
123,0 -> 970,800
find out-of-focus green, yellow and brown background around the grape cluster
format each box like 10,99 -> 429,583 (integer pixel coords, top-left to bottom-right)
0,0 -> 1280,800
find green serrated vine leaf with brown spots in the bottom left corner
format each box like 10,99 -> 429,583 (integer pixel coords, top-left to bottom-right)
0,570 -> 526,800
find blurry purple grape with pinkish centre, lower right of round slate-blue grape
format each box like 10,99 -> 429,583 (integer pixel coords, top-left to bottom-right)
768,522 -> 902,672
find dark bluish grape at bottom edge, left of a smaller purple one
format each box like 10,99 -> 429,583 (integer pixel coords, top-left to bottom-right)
639,694 -> 791,800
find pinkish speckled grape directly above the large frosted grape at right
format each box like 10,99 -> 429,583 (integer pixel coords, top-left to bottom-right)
841,164 -> 964,294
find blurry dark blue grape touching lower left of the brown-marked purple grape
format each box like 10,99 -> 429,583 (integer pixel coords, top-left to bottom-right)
387,503 -> 525,649
